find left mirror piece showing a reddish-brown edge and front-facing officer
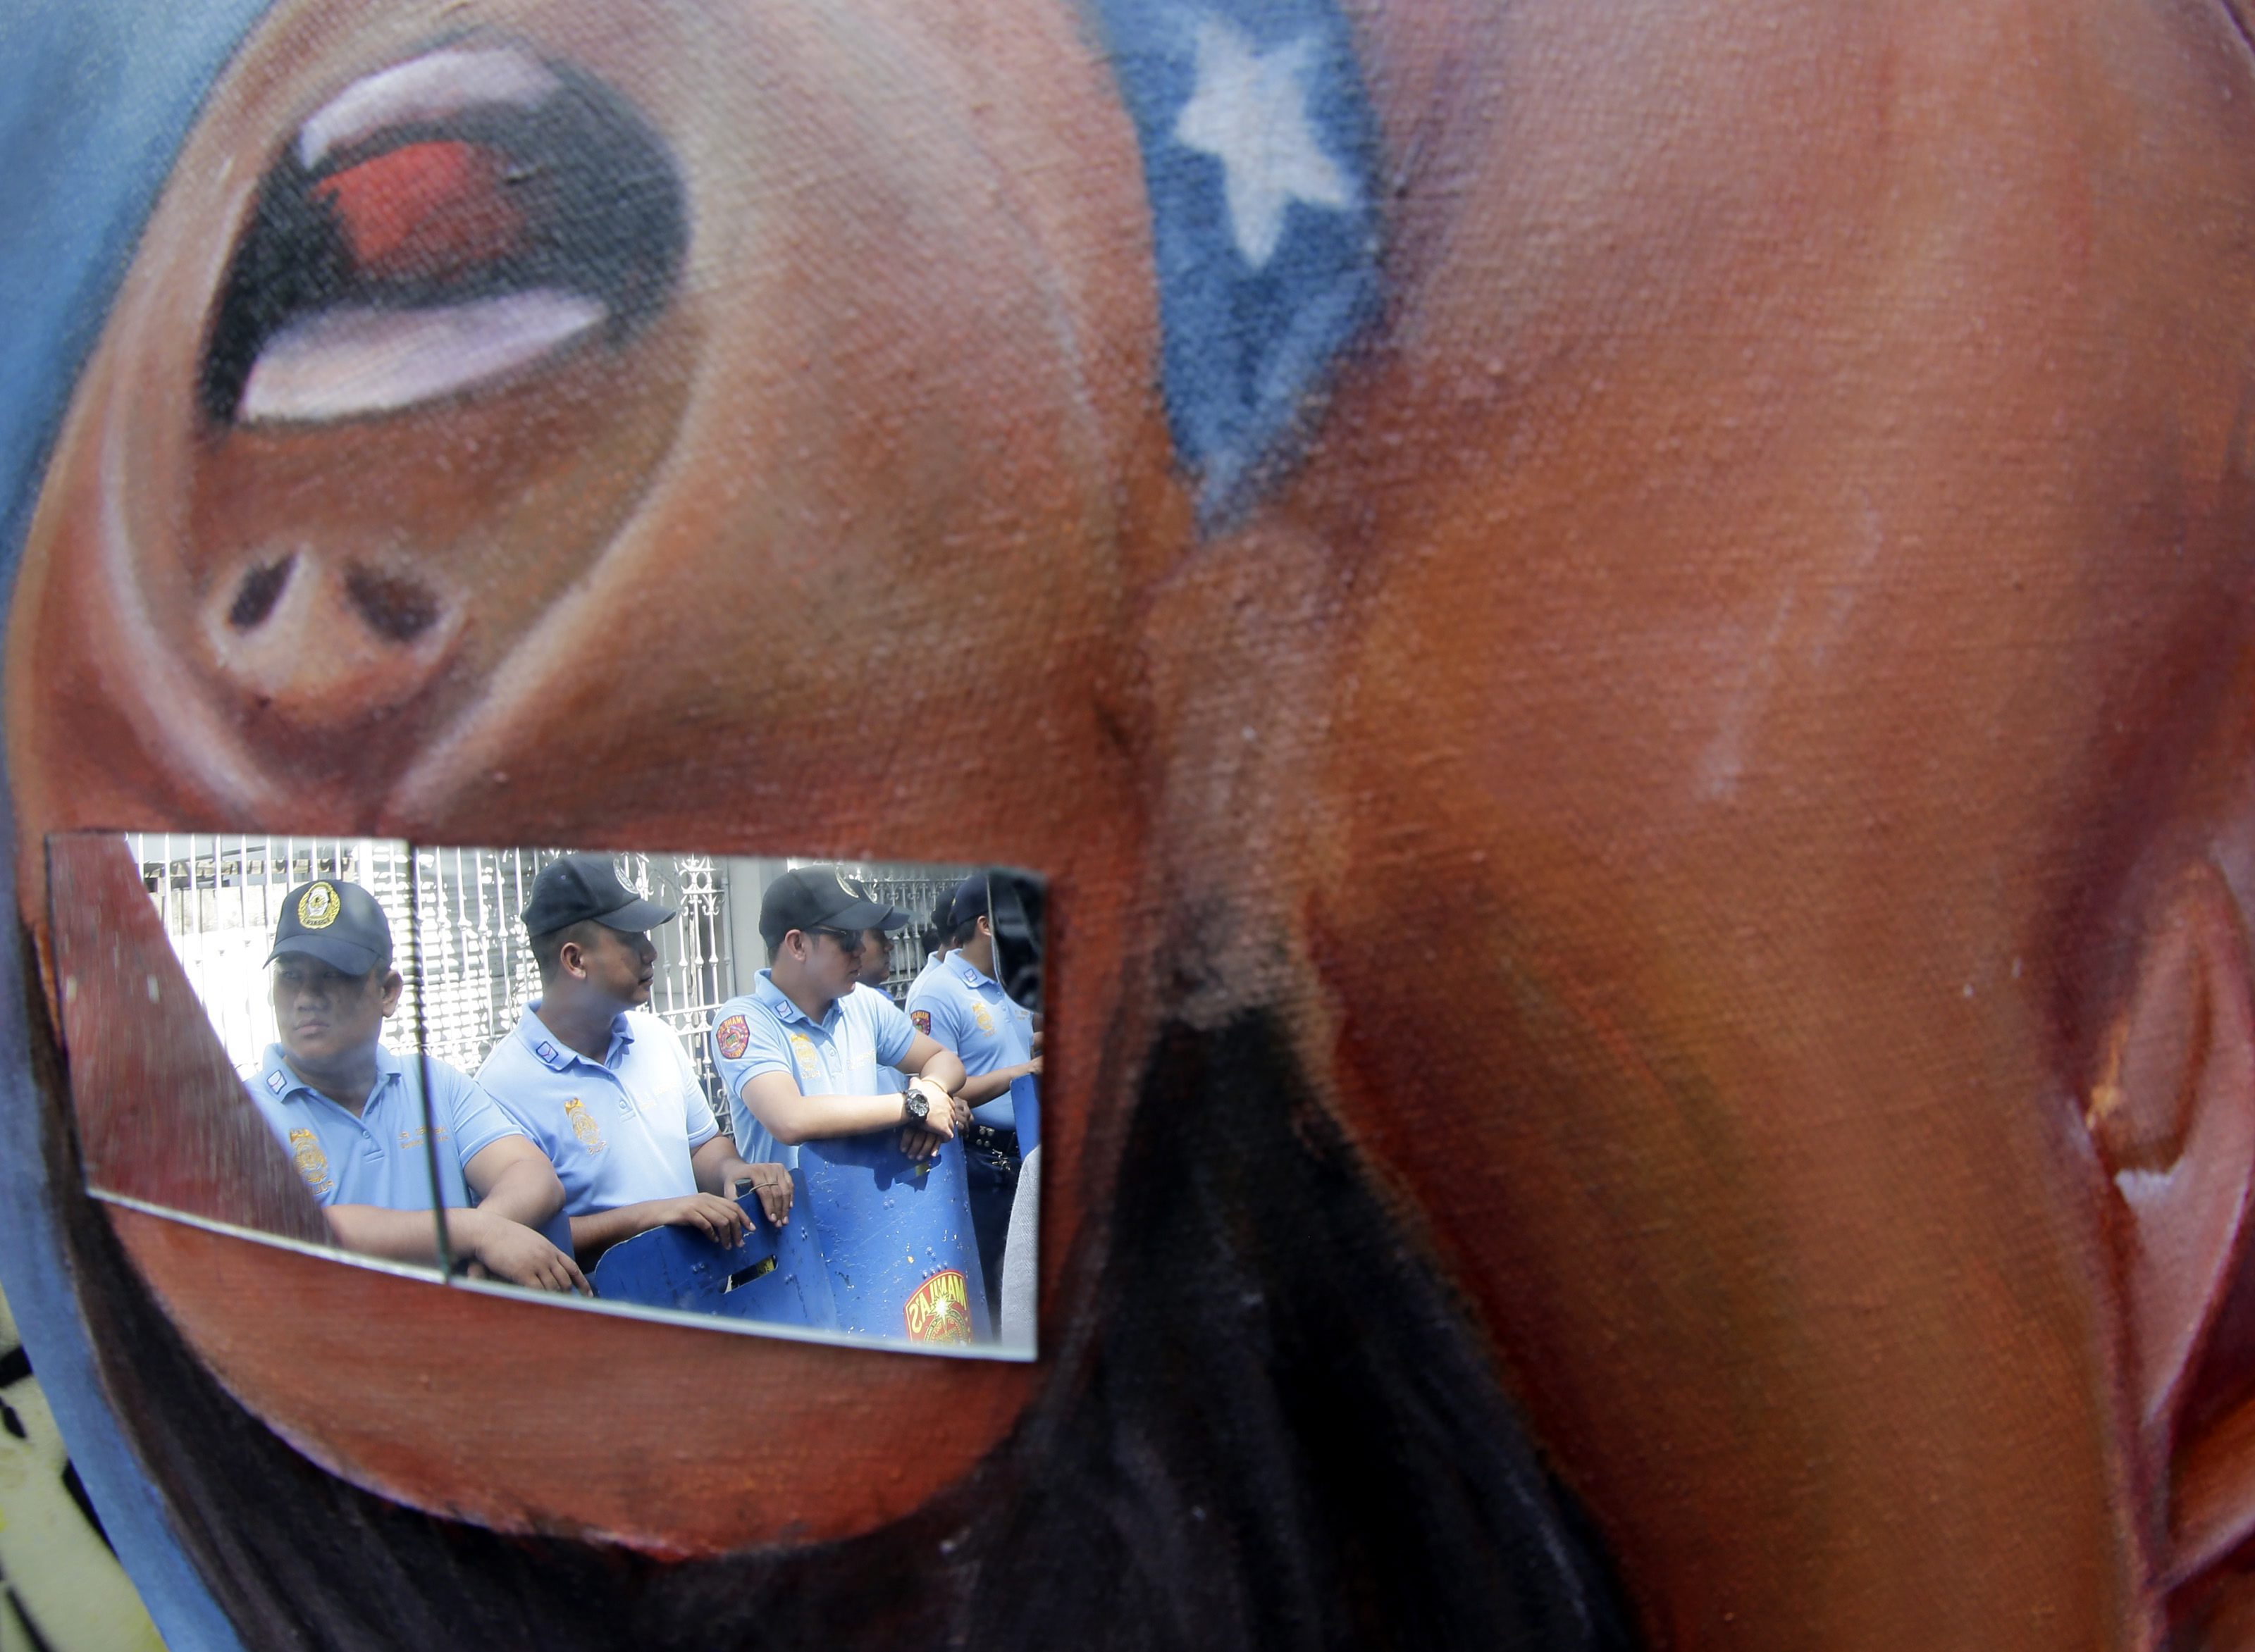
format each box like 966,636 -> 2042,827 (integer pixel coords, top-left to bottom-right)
47,834 -> 442,1271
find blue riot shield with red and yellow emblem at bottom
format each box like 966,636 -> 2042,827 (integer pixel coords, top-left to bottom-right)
791,1129 -> 994,1346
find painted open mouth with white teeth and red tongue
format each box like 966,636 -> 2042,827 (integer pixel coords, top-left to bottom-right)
199,45 -> 688,423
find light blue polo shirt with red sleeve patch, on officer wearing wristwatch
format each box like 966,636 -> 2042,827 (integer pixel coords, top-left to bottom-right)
712,969 -> 915,1169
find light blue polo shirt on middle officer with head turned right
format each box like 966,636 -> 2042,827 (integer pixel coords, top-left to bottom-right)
478,1003 -> 719,1217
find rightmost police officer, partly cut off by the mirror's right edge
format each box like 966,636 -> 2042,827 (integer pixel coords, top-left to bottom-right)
909,872 -> 1042,1321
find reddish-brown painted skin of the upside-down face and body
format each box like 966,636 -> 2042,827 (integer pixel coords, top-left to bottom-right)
9,0 -> 2255,1650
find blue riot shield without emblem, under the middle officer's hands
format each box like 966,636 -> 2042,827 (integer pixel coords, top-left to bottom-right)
588,1174 -> 839,1330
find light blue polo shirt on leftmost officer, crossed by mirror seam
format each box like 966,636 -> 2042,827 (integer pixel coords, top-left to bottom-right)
250,1043 -> 519,1210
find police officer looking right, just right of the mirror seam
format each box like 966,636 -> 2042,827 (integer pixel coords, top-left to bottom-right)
478,854 -> 791,1265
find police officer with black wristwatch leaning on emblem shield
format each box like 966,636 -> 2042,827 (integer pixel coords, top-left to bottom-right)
712,865 -> 970,1165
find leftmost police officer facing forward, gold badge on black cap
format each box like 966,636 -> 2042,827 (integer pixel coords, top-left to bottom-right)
250,879 -> 586,1291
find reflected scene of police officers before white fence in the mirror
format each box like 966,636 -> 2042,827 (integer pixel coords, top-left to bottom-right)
70,834 -> 1044,1355
